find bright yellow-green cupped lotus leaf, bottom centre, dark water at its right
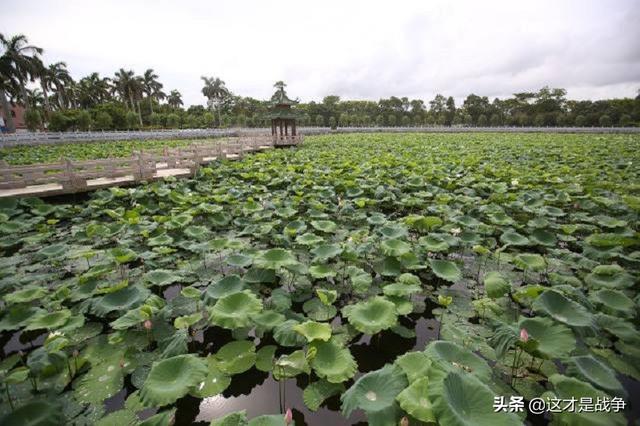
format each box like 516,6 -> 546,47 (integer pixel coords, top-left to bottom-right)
310,340 -> 358,383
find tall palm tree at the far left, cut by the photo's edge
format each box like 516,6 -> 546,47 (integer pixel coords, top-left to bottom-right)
0,34 -> 43,132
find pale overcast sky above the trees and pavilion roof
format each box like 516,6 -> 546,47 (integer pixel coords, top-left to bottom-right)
0,0 -> 640,106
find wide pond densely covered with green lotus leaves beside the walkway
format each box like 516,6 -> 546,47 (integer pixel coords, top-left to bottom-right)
0,134 -> 640,426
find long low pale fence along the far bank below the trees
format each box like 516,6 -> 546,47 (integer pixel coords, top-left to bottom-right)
0,126 -> 640,147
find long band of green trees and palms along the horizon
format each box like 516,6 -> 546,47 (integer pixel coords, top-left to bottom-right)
0,34 -> 640,131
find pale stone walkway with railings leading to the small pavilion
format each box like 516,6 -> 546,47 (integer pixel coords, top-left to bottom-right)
0,136 -> 303,198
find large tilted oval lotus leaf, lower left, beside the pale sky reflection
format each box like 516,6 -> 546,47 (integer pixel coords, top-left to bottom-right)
140,355 -> 208,407
